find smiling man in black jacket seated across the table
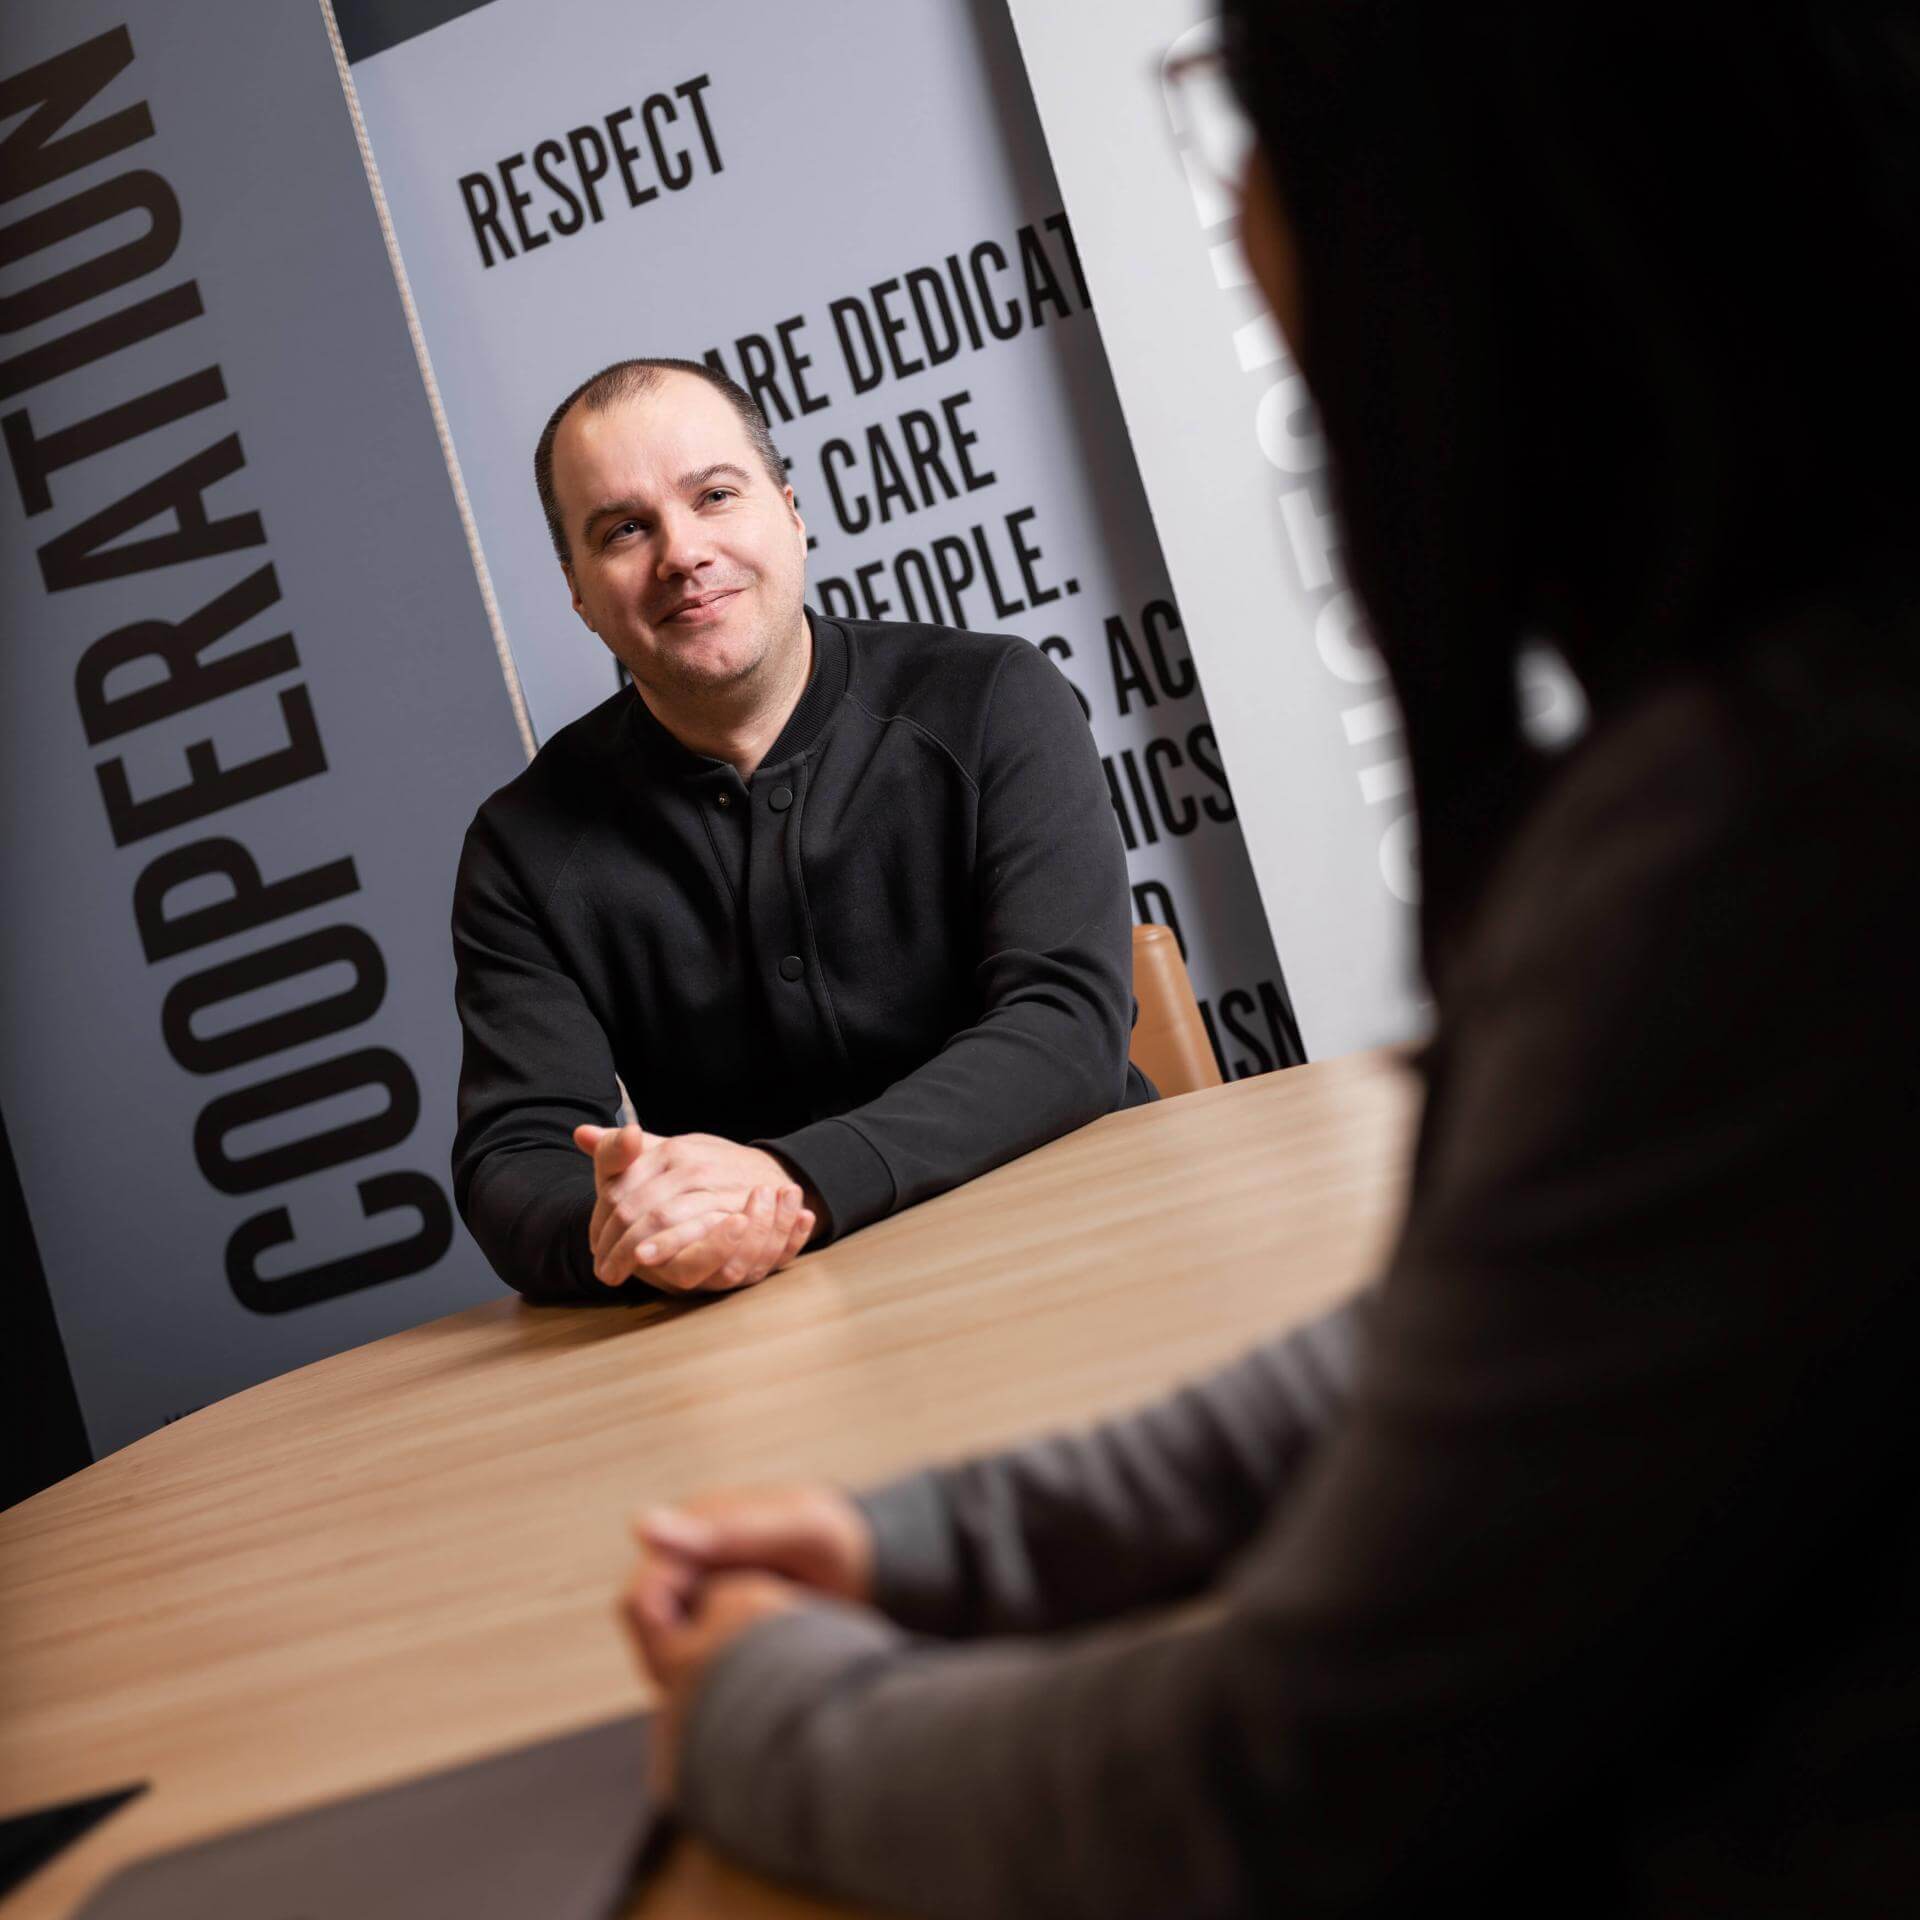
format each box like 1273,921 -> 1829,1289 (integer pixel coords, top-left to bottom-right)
453,361 -> 1152,1300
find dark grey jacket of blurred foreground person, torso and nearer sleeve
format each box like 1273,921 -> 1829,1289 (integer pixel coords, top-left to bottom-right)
682,683 -> 1920,1920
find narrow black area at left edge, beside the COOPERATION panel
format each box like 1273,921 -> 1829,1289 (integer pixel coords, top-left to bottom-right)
0,1121 -> 94,1507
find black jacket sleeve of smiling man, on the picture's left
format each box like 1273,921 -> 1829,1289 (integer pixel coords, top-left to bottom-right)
453,812 -> 629,1302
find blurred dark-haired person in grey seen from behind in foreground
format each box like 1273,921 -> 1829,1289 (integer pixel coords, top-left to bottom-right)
626,0 -> 1920,1920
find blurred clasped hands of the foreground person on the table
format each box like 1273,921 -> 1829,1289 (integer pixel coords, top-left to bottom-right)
620,1484 -> 874,1805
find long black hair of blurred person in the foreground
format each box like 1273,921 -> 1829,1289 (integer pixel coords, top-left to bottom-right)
1223,0 -> 1920,960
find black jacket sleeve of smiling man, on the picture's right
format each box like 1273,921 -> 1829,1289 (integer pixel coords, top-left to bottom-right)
758,643 -> 1133,1236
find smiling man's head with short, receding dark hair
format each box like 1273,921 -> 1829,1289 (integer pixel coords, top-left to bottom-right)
553,372 -> 806,701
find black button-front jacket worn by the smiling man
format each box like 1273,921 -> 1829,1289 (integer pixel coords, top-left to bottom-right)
453,611 -> 1154,1300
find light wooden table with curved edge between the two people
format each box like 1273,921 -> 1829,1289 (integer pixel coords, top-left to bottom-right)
0,1056 -> 1413,1920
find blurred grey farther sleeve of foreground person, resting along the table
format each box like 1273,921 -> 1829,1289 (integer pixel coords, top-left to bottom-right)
860,1302 -> 1365,1638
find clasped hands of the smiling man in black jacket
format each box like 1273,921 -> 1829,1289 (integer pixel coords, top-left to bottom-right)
574,1127 -> 818,1294
